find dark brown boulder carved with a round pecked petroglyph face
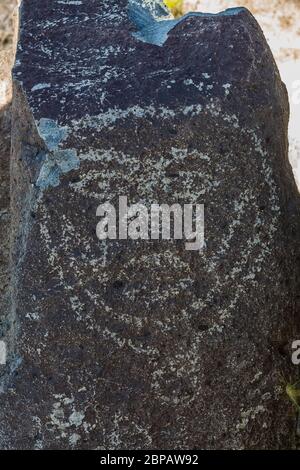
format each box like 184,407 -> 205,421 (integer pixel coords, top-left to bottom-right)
0,0 -> 299,449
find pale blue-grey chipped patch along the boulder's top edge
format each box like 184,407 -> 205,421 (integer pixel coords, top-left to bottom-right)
128,0 -> 246,47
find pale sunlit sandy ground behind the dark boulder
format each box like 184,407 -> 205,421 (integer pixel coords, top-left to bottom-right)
0,0 -> 300,188
